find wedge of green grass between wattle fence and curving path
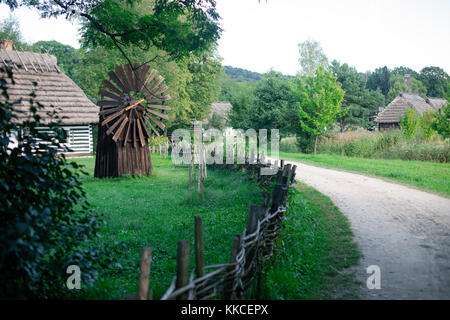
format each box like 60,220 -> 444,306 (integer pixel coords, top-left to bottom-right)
263,183 -> 360,300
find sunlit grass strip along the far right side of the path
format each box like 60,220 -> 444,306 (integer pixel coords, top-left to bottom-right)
280,152 -> 450,197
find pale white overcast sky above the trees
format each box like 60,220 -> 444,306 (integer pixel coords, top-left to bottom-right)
0,0 -> 450,75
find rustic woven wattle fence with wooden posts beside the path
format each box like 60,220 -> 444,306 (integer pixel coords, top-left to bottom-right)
126,155 -> 296,300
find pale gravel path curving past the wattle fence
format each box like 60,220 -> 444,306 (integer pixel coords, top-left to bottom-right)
278,161 -> 450,299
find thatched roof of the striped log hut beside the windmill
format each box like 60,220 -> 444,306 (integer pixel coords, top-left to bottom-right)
0,49 -> 99,125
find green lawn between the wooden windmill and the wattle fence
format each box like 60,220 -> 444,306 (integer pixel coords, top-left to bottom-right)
77,156 -> 262,299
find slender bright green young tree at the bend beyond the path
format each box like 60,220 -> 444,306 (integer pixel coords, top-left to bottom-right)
294,66 -> 347,154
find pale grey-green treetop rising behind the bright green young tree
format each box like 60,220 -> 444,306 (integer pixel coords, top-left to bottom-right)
298,39 -> 328,77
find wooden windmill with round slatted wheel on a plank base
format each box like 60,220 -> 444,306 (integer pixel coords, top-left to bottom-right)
95,64 -> 170,178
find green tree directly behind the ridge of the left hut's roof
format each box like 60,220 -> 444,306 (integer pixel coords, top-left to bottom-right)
31,40 -> 80,79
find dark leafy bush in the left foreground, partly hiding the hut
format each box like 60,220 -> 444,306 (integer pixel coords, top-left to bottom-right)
0,70 -> 102,299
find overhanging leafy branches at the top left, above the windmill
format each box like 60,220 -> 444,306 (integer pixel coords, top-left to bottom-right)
1,0 -> 221,63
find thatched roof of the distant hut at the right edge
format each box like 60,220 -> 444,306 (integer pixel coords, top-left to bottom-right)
374,92 -> 446,123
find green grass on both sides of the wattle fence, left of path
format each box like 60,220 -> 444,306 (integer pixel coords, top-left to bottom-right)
77,155 -> 357,299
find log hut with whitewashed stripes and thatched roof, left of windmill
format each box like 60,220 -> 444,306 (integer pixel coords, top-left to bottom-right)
0,40 -> 99,157
